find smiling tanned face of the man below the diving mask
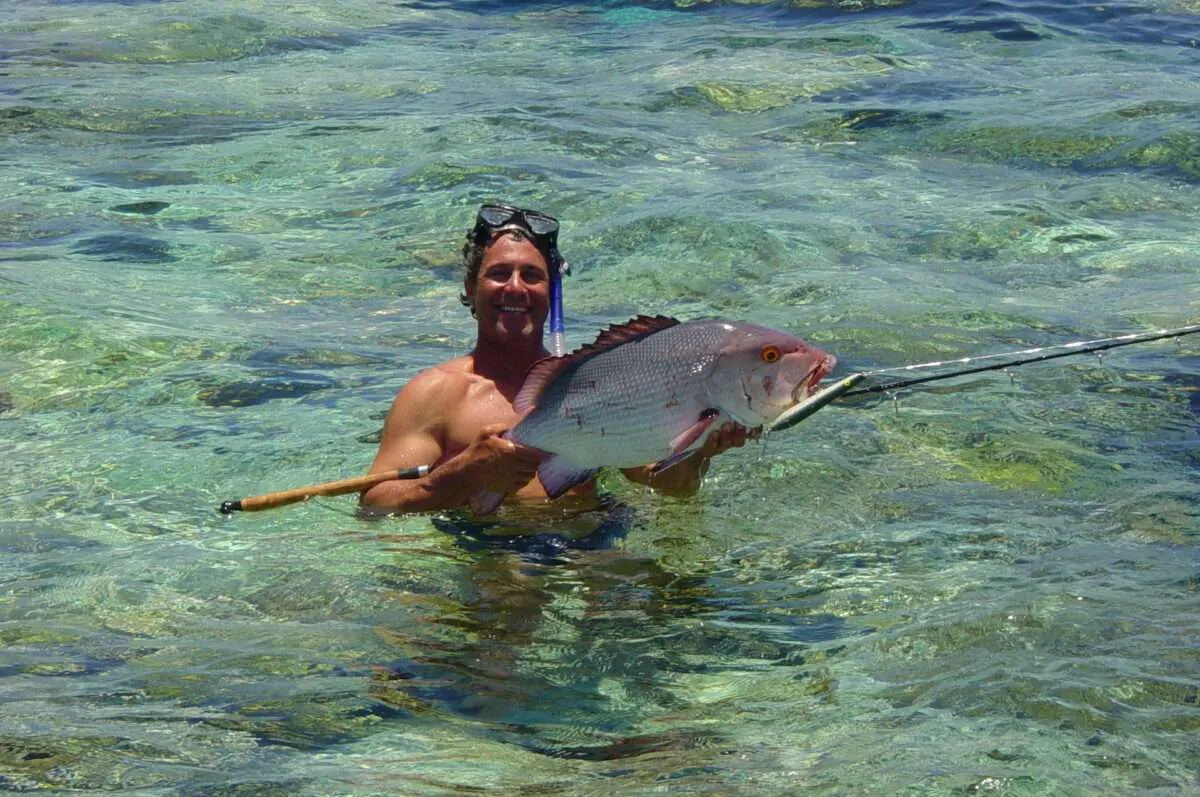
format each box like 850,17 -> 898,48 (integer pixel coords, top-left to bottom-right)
466,234 -> 550,337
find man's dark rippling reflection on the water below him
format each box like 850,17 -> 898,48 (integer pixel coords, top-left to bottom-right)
372,502 -> 712,760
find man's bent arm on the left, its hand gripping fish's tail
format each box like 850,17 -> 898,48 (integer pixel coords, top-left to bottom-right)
360,370 -> 538,513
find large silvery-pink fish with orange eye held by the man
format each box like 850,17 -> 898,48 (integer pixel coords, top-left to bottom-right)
472,316 -> 836,514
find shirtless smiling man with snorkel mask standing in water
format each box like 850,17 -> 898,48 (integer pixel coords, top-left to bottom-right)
361,204 -> 750,513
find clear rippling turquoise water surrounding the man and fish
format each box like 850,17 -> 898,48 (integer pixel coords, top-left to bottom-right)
0,0 -> 1200,797
